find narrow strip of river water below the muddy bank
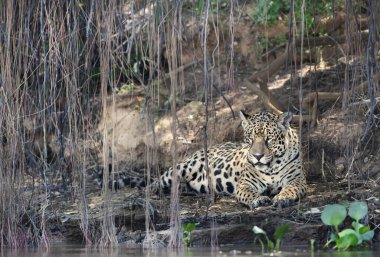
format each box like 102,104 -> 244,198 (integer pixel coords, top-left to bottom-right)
0,244 -> 380,257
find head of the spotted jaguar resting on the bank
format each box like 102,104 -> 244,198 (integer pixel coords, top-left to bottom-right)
240,111 -> 293,170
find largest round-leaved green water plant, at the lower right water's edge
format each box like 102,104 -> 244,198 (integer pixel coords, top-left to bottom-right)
321,201 -> 374,250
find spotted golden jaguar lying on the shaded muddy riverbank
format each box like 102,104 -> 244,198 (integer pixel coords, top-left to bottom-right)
160,112 -> 307,208
